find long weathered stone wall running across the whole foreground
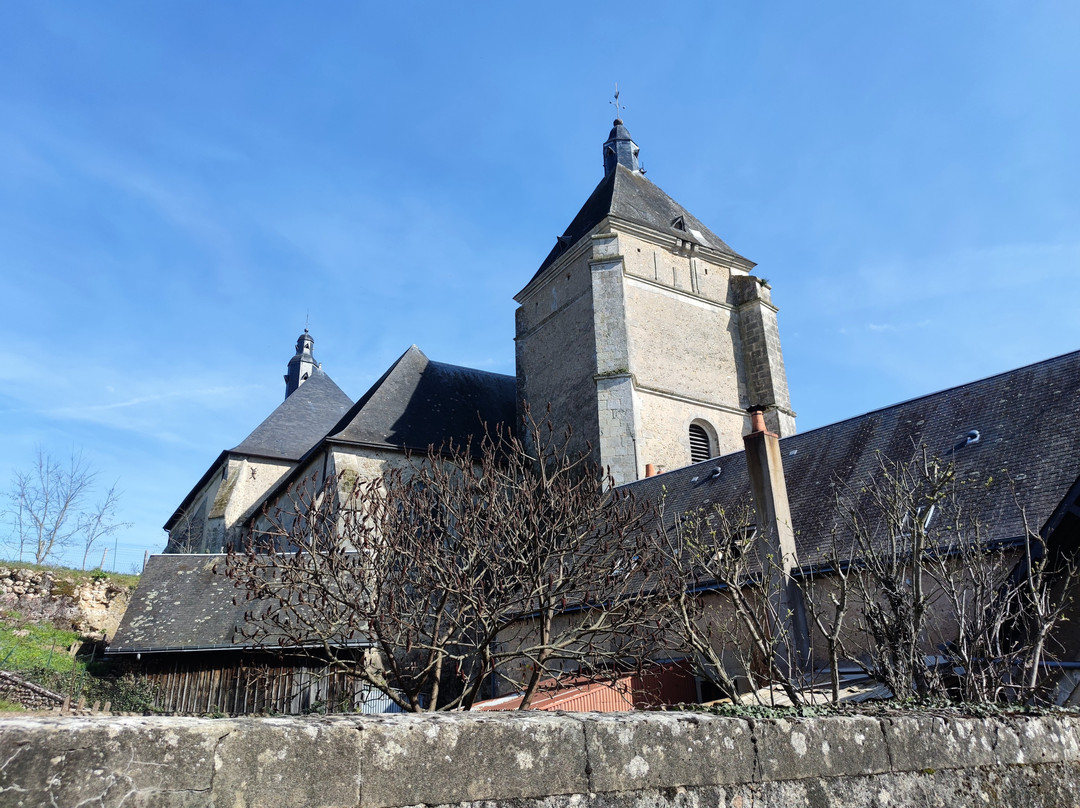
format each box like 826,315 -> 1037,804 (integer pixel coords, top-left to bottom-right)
0,713 -> 1080,808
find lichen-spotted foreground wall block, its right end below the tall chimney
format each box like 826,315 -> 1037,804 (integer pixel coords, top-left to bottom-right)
584,713 -> 754,792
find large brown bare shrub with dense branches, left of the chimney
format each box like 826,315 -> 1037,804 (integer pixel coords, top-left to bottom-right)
224,415 -> 660,711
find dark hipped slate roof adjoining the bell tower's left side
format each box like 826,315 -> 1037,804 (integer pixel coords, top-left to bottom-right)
326,346 -> 516,452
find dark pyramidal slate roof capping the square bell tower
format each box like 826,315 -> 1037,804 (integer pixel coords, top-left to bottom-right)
529,164 -> 753,283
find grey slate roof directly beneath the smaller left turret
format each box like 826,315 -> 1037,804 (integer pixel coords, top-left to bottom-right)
230,368 -> 352,460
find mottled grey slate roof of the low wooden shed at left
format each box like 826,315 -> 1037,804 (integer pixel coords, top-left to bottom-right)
108,554 -> 263,654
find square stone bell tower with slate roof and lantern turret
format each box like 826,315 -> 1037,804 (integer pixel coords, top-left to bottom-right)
514,119 -> 795,484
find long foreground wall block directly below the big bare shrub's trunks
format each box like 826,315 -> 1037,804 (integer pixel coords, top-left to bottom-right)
359,713 -> 589,808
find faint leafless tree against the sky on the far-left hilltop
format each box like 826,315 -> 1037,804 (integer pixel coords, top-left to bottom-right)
8,447 -> 125,568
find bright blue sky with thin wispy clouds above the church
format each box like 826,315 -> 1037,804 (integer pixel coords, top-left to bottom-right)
0,0 -> 1080,571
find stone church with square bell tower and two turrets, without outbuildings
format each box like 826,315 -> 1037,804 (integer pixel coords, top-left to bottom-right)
165,119 -> 795,552
